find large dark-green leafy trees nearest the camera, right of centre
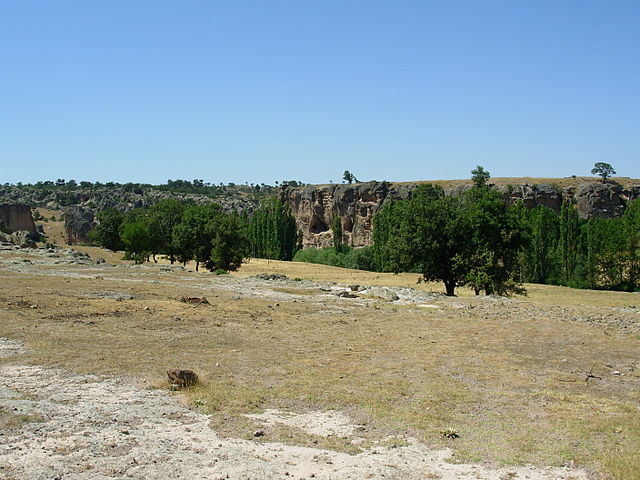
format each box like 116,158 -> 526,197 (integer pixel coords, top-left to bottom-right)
373,182 -> 527,295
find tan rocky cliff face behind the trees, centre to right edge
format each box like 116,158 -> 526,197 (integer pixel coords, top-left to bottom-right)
281,182 -> 640,247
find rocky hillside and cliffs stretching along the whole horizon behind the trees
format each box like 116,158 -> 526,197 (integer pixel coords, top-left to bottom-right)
0,177 -> 640,247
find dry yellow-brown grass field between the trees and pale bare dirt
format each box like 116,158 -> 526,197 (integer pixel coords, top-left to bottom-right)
0,240 -> 640,480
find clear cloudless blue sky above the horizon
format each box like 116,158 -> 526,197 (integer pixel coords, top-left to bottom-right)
0,0 -> 640,184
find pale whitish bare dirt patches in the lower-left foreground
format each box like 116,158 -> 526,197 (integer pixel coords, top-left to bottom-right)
0,339 -> 587,480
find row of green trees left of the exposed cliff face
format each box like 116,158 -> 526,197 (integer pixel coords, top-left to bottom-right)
91,199 -> 299,271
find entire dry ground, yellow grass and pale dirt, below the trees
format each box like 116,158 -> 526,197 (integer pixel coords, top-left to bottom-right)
0,247 -> 640,479
